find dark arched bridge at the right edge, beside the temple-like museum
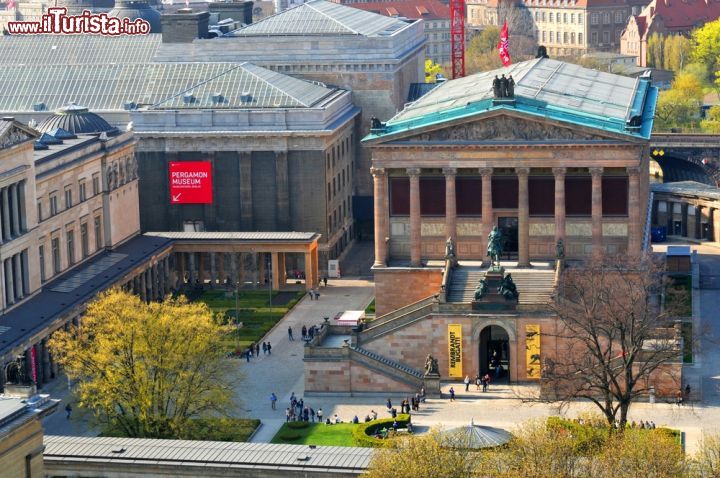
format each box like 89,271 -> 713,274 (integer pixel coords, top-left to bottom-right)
650,133 -> 720,186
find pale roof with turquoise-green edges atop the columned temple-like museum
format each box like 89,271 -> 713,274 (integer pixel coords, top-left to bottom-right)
363,58 -> 658,141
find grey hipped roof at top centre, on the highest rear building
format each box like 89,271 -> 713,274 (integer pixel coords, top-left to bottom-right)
228,0 -> 407,37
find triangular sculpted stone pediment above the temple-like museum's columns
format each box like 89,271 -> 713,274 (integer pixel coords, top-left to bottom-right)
386,115 -> 619,144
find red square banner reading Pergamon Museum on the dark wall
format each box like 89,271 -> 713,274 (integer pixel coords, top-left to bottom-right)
170,161 -> 212,204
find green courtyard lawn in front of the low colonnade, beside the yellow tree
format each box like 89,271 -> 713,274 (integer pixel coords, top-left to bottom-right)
197,290 -> 305,352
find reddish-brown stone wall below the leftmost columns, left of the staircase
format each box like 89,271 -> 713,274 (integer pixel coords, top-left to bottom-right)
374,267 -> 442,316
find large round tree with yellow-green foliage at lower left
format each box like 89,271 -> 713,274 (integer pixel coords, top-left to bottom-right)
50,290 -> 232,438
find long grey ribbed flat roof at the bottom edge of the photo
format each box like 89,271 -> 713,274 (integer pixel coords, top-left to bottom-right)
44,435 -> 374,476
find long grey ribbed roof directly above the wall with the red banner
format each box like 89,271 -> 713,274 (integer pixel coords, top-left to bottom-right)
0,61 -> 335,112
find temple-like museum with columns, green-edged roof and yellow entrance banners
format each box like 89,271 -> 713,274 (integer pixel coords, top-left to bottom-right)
305,59 -> 676,393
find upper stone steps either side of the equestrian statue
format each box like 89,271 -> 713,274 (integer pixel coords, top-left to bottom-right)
447,265 -> 555,305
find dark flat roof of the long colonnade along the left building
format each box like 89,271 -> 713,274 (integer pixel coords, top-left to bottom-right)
0,235 -> 172,360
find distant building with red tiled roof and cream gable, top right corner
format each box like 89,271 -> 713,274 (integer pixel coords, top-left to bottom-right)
620,0 -> 720,66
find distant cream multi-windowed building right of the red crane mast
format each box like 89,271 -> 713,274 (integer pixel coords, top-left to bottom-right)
467,0 -> 647,56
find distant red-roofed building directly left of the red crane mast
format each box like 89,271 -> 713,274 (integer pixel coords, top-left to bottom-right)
340,0 -> 451,65
